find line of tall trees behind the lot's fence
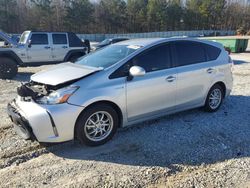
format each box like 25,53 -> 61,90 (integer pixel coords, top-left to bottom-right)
0,0 -> 250,33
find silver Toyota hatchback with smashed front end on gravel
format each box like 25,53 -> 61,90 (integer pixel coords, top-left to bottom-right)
7,38 -> 233,146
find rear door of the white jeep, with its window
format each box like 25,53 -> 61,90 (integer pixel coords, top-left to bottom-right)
52,33 -> 69,61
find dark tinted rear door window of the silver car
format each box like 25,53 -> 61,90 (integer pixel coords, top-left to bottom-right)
175,41 -> 206,66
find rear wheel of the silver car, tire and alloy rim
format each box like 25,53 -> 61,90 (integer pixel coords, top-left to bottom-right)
204,84 -> 224,112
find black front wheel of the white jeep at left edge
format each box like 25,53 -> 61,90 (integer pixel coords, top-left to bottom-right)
0,58 -> 18,79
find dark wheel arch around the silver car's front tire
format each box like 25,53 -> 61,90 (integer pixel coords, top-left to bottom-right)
74,100 -> 123,138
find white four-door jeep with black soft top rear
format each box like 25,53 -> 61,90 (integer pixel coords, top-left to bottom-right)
0,31 -> 88,79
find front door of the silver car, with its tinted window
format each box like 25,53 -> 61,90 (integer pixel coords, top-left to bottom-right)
126,44 -> 177,121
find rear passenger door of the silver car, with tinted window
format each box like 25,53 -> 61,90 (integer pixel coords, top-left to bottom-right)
174,41 -> 215,109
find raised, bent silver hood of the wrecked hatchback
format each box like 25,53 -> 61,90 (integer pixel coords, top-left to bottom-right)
31,62 -> 102,86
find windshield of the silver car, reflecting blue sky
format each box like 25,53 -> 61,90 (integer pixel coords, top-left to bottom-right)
76,45 -> 140,68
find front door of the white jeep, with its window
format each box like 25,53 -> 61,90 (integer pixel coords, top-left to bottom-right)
27,32 -> 53,62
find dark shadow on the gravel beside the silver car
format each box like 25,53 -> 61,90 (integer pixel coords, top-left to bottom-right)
47,95 -> 250,169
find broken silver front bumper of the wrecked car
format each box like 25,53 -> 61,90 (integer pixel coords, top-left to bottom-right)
7,97 -> 83,143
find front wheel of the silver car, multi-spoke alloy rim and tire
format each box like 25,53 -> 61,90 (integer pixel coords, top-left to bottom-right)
76,104 -> 119,146
